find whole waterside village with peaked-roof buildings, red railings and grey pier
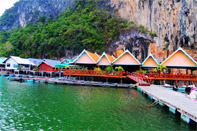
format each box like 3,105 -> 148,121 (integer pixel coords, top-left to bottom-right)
0,47 -> 197,124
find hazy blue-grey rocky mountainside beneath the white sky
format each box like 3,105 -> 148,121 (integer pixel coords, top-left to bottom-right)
0,0 -> 75,30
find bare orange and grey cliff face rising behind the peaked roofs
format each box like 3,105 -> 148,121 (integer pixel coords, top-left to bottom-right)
110,0 -> 197,62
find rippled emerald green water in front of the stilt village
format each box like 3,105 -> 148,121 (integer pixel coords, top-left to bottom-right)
0,77 -> 195,131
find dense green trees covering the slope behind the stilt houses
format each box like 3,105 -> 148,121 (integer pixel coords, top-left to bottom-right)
0,0 -> 130,58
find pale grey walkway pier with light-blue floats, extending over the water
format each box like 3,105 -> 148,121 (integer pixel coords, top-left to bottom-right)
138,85 -> 197,123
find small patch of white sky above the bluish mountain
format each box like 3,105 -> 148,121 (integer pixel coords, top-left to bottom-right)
0,0 -> 19,16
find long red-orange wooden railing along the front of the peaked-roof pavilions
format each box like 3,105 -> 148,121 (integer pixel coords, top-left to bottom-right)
63,69 -> 197,83
